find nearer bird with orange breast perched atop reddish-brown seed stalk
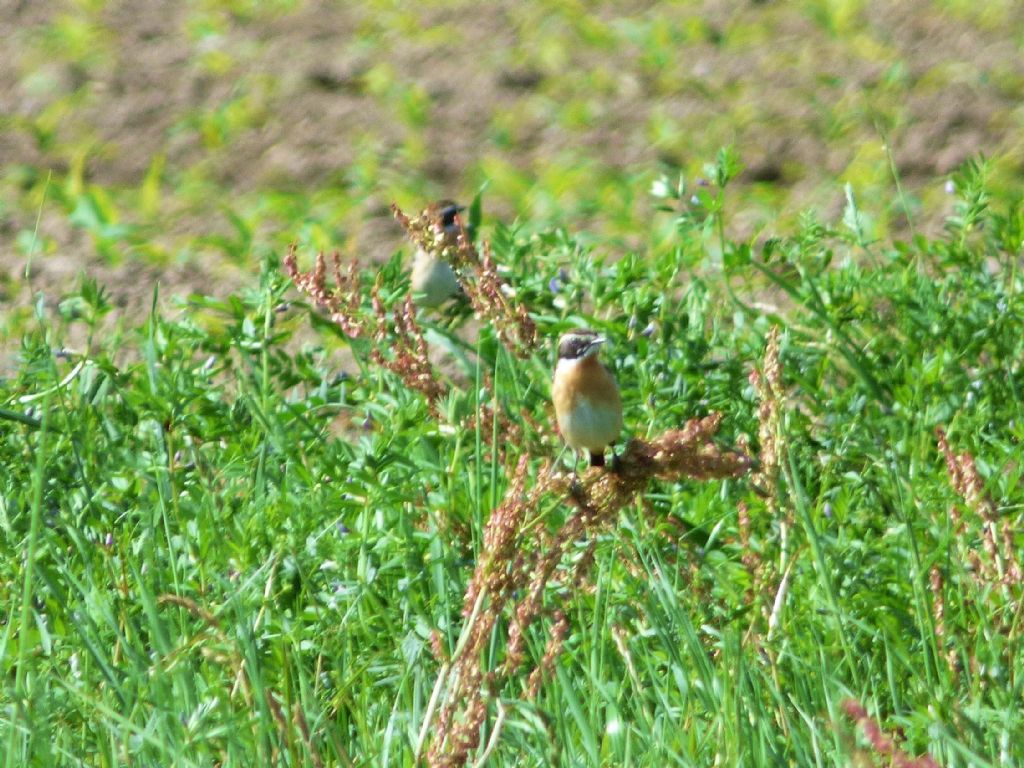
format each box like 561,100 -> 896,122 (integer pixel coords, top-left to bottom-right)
551,329 -> 623,471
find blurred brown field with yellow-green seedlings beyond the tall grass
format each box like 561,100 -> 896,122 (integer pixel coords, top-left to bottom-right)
0,0 -> 1024,321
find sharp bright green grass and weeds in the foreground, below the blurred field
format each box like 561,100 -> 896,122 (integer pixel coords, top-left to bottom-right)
0,151 -> 1024,766
